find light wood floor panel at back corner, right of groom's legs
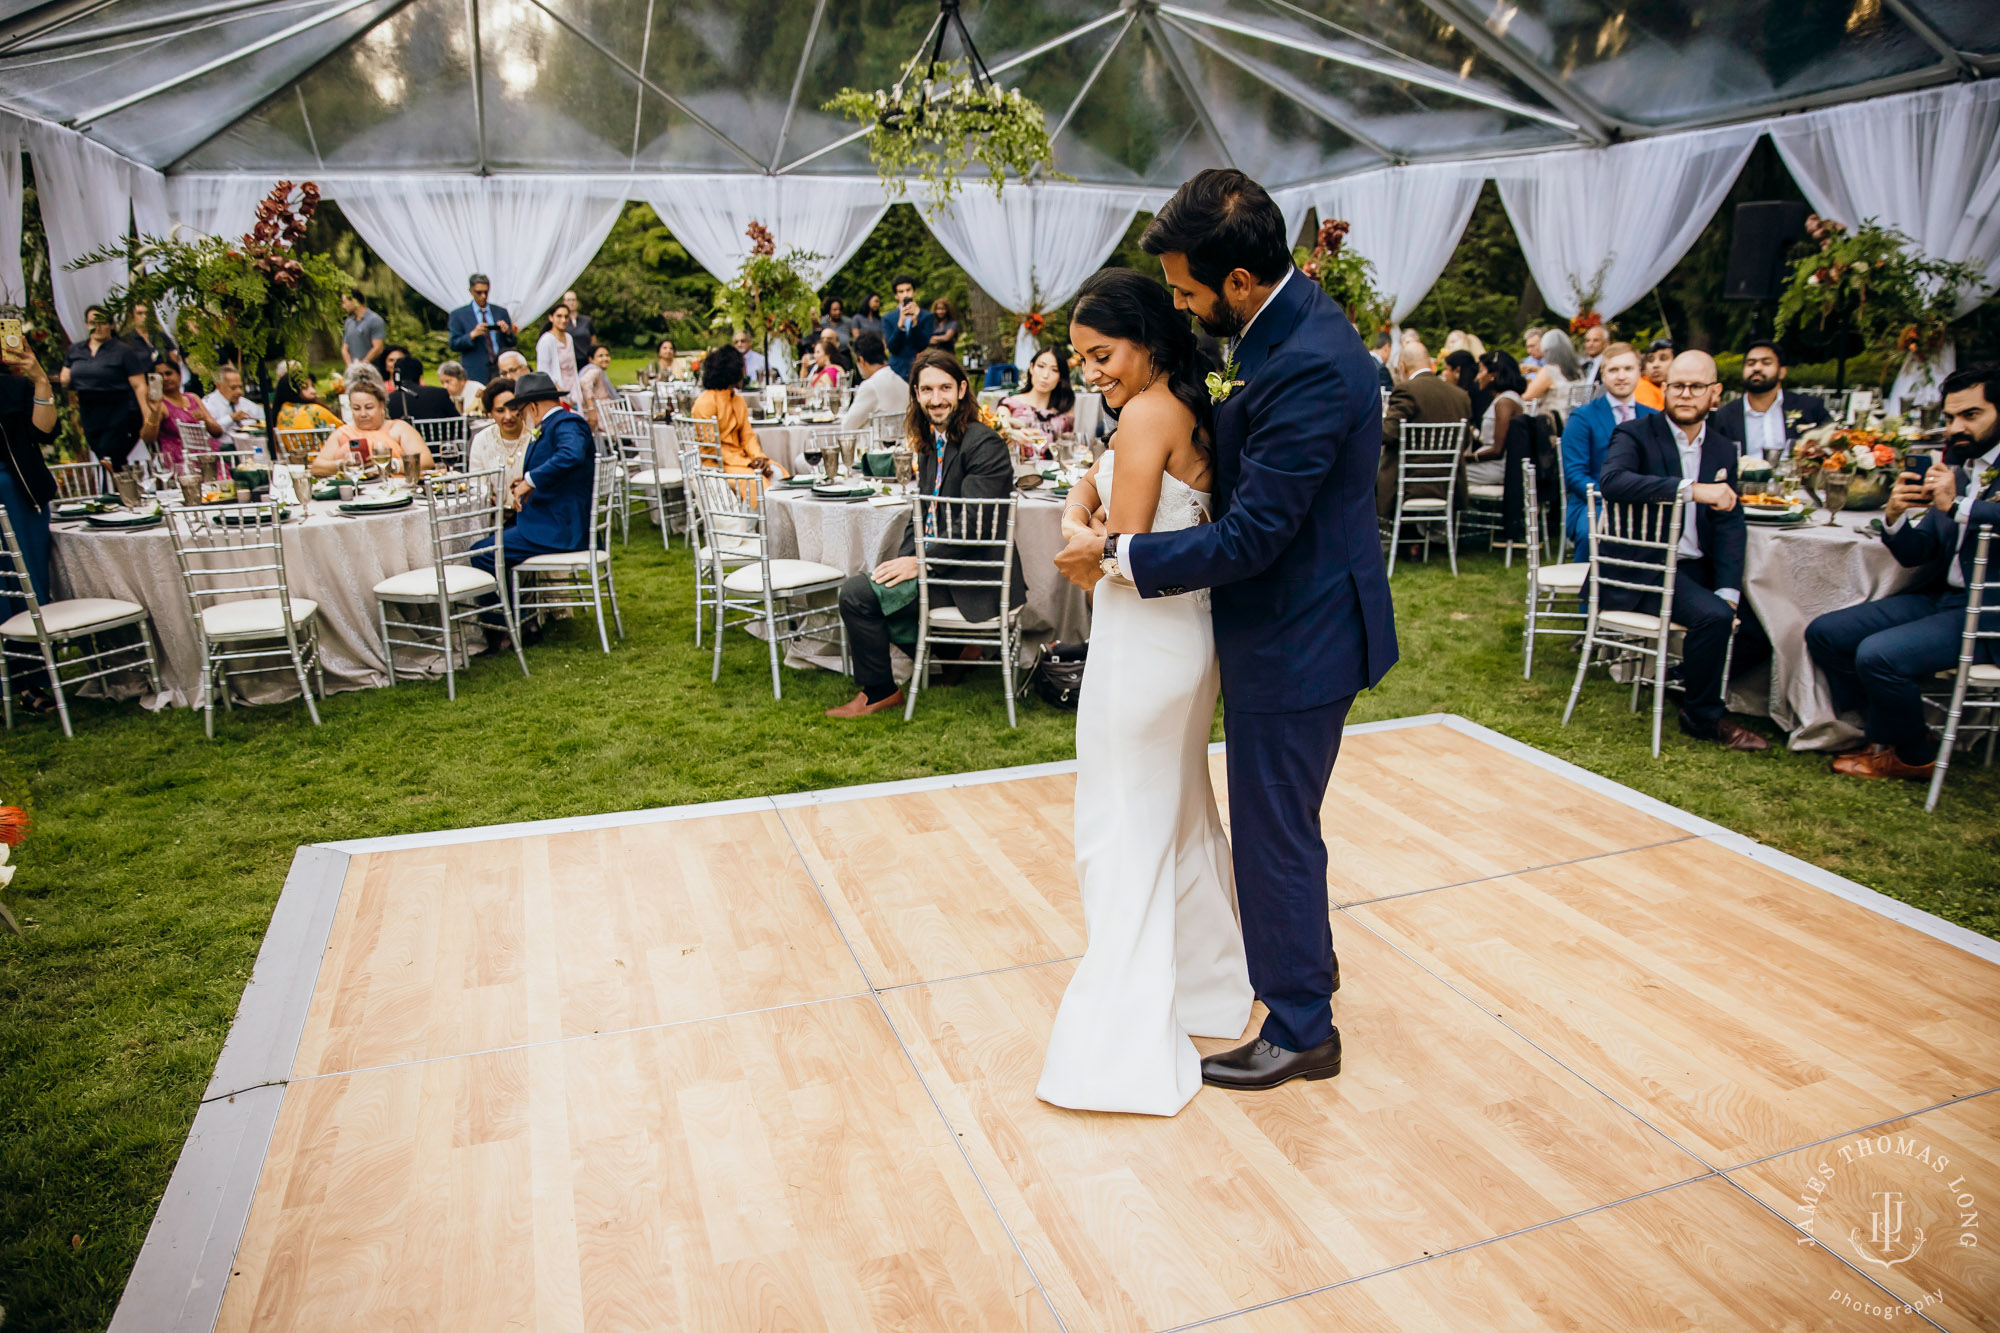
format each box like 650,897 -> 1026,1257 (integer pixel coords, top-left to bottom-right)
1210,727 -> 1688,903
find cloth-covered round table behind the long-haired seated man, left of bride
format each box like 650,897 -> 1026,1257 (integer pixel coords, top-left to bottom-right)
764,486 -> 1090,671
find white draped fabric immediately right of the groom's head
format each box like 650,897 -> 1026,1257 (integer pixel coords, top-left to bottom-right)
1312,162 -> 1486,322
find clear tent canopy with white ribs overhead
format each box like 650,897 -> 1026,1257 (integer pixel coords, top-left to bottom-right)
0,0 -> 2000,190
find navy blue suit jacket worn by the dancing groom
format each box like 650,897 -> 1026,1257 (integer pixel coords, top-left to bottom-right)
1126,270 -> 1396,713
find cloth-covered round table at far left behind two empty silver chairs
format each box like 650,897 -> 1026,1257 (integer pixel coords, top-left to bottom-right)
50,500 -> 472,709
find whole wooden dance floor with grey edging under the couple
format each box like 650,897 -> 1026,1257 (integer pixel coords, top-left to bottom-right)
112,717 -> 2000,1333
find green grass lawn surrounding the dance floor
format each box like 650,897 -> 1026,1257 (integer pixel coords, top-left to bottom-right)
0,528 -> 2000,1333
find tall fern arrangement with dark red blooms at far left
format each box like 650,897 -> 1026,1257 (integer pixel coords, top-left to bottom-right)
68,180 -> 350,454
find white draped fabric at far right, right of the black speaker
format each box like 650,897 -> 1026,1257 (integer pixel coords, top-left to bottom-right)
1770,82 -> 2000,398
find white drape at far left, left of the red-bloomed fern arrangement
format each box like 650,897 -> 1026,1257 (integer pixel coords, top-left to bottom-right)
22,120 -> 166,338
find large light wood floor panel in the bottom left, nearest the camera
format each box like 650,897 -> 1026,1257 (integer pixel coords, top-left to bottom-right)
218,997 -> 1054,1333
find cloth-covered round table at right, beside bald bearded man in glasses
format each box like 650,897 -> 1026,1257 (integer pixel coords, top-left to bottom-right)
1730,512 -> 1922,751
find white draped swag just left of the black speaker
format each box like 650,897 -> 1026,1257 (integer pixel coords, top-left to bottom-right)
1492,124 -> 1764,318
